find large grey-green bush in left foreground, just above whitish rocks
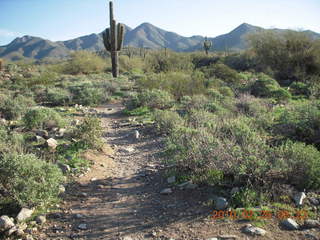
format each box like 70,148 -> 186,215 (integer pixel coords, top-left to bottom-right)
0,153 -> 62,207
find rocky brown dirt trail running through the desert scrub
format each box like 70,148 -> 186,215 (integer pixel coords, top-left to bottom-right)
38,104 -> 318,240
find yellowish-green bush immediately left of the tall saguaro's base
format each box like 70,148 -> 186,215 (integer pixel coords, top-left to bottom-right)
63,51 -> 106,74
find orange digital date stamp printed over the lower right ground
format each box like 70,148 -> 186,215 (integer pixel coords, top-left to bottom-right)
211,209 -> 308,220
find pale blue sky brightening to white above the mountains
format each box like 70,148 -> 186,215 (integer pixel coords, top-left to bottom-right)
0,0 -> 320,46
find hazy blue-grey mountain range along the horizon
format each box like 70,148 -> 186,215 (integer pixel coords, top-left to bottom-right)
0,23 -> 320,60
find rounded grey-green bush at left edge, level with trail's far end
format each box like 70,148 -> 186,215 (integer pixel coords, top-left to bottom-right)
0,94 -> 35,120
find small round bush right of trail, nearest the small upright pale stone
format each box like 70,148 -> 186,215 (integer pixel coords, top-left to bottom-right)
154,110 -> 184,134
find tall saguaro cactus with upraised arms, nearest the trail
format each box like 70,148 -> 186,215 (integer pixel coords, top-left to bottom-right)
102,1 -> 124,77
